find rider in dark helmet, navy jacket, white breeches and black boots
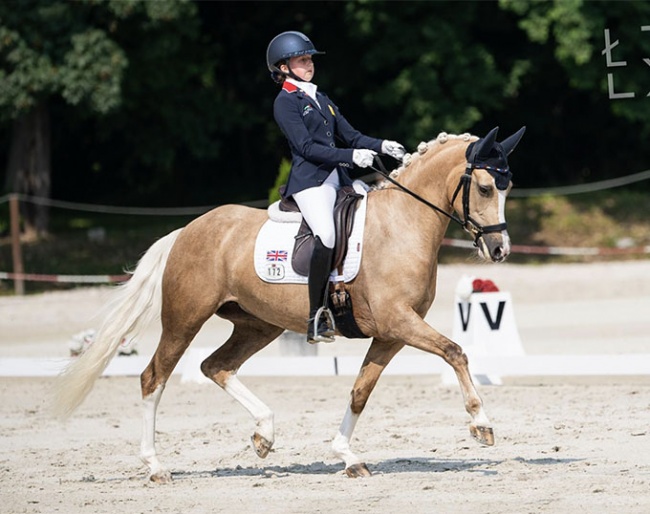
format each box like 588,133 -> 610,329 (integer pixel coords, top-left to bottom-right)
266,31 -> 404,343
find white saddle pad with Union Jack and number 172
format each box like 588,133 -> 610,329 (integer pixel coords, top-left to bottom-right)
254,181 -> 367,284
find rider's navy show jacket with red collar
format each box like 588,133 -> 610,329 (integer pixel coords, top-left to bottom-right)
273,82 -> 383,198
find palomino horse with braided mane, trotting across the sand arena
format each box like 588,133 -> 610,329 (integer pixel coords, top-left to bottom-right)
54,128 -> 524,482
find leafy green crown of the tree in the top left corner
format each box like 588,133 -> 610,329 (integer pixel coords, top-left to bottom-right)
0,0 -> 128,119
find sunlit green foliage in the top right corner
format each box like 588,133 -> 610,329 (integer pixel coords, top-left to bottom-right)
500,0 -> 650,126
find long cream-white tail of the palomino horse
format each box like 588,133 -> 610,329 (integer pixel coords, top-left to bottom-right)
52,229 -> 182,418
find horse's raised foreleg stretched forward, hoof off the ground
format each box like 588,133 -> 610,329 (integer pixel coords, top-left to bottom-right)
404,313 -> 494,446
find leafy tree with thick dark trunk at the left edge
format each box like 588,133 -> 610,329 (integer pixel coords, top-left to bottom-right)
0,0 -> 196,234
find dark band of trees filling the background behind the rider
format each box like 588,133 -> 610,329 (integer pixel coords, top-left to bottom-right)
0,0 -> 650,206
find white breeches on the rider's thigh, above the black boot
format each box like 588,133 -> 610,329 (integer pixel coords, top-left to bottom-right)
293,171 -> 339,248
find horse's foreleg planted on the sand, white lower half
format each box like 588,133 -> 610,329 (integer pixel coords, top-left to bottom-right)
332,339 -> 404,478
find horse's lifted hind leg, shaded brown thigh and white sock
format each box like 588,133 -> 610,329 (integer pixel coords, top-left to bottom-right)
201,305 -> 283,458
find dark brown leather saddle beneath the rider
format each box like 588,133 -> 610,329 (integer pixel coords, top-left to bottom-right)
279,186 -> 363,276
